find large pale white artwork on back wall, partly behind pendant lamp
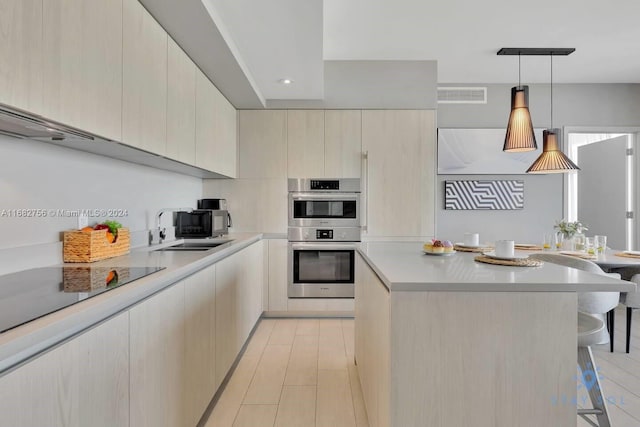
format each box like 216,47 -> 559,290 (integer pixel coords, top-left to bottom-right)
438,129 -> 542,175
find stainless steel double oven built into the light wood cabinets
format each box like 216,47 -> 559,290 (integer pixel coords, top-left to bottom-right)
288,178 -> 360,298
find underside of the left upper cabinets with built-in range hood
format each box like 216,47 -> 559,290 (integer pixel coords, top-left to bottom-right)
0,104 -> 228,178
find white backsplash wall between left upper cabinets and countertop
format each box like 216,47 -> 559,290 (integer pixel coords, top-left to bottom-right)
0,135 -> 202,274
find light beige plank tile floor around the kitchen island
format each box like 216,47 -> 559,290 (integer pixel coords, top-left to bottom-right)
206,306 -> 640,427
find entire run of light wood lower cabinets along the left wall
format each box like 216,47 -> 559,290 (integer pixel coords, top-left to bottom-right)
0,241 -> 264,427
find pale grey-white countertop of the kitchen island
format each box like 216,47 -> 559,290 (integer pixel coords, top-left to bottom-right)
359,242 -> 635,292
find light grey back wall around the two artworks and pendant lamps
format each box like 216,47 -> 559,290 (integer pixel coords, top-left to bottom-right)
436,82 -> 640,243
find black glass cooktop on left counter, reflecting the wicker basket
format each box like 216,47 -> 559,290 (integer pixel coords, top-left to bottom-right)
0,266 -> 165,333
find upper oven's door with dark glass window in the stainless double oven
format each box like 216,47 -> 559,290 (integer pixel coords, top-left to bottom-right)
289,193 -> 360,227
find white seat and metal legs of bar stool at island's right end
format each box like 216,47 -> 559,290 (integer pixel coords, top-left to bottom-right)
578,312 -> 611,427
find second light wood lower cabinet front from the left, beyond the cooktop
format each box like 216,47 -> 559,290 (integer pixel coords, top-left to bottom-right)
129,282 -> 185,427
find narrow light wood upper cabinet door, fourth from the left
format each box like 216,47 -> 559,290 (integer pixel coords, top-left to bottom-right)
166,37 -> 196,165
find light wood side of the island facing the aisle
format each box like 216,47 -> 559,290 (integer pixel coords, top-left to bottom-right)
355,254 -> 391,427
